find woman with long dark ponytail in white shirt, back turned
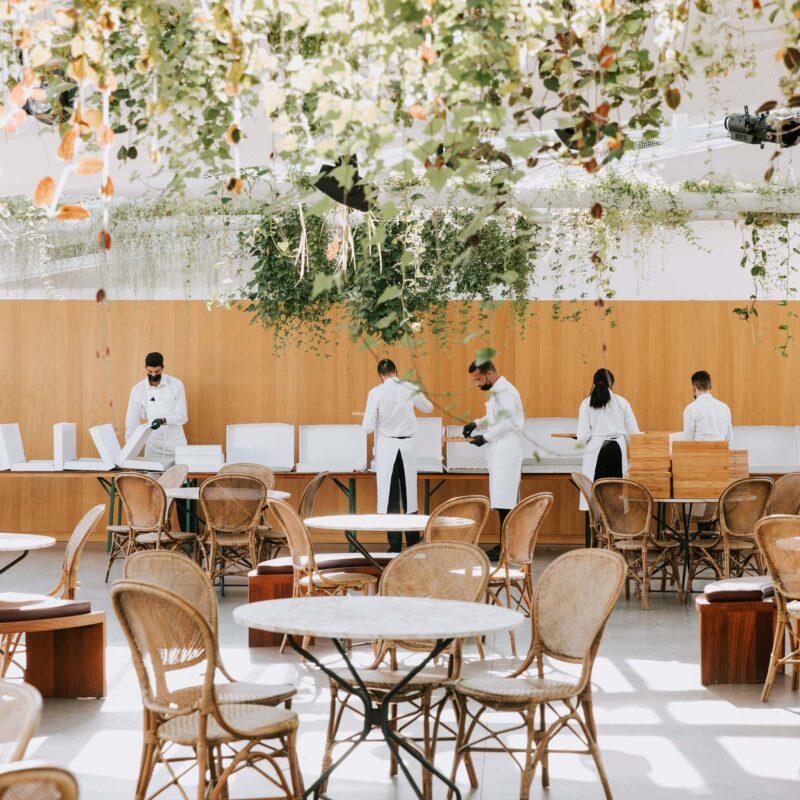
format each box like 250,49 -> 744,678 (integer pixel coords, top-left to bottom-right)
577,369 -> 639,511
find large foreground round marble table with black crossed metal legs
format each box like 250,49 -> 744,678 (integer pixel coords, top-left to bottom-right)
233,596 -> 526,800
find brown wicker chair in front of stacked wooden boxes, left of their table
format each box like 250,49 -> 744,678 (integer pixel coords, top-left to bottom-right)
592,478 -> 684,611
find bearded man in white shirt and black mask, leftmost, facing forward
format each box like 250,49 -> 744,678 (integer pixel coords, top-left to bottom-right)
125,353 -> 189,464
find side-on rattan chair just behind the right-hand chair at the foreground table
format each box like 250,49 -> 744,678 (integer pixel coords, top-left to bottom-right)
486,492 -> 555,658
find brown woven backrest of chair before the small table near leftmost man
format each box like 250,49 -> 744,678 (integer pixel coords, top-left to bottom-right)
200,474 -> 267,533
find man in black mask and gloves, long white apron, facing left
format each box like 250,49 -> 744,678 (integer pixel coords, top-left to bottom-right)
463,361 -> 525,559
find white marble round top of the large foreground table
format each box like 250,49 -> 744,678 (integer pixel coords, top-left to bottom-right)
233,595 -> 527,641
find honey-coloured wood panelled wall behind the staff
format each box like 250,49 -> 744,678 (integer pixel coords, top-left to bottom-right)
0,300 -> 800,540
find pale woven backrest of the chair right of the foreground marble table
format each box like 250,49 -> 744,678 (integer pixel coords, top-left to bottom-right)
531,550 -> 626,690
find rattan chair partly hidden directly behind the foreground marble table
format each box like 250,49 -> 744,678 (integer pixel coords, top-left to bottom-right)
322,542 -> 491,800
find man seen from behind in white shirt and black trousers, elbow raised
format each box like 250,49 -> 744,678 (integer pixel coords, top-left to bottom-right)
361,358 -> 433,553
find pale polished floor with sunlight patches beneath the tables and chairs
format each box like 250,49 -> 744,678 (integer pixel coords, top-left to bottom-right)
10,545 -> 800,800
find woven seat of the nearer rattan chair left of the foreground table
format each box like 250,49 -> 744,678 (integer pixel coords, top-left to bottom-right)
158,703 -> 297,745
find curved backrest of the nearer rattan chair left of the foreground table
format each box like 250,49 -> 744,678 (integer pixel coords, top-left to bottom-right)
111,580 -> 216,714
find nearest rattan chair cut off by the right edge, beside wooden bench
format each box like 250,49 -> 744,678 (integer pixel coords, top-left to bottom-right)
754,514 -> 800,703
